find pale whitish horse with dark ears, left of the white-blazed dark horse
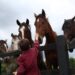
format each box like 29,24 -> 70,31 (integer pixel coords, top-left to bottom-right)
11,33 -> 20,51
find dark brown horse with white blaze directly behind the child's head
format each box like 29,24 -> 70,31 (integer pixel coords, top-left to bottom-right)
16,19 -> 33,47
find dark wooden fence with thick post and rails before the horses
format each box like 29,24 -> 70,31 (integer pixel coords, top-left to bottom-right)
0,35 -> 75,75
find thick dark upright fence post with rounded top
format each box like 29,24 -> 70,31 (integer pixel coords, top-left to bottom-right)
56,35 -> 70,75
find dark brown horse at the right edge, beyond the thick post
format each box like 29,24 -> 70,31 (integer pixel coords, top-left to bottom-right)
62,16 -> 75,52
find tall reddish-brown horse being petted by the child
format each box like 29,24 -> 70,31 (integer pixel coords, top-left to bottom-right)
34,9 -> 58,69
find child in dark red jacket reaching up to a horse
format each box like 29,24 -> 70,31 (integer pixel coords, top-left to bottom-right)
17,33 -> 40,75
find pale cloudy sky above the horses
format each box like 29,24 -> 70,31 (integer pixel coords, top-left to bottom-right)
0,0 -> 75,56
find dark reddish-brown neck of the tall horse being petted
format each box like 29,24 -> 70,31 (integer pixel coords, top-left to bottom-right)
45,25 -> 56,44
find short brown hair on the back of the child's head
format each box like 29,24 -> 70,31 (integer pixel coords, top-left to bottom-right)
18,39 -> 30,51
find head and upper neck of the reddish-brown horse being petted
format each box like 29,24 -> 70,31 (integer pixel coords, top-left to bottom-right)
34,9 -> 55,43
